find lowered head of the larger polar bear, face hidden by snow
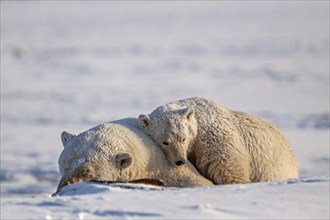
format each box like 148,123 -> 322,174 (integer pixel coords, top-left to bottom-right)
58,120 -> 142,191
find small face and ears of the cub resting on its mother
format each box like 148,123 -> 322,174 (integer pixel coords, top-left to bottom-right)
139,106 -> 197,166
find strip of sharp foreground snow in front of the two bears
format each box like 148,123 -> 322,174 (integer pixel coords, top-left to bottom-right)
2,177 -> 329,219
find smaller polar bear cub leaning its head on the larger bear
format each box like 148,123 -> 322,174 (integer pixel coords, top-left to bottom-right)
139,97 -> 298,184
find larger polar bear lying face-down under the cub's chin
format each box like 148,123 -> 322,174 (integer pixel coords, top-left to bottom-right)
57,118 -> 213,191
